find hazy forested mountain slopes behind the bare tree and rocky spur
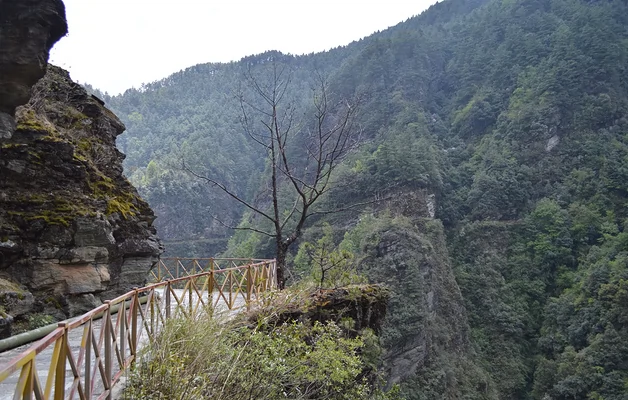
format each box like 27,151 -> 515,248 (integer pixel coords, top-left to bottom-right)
104,0 -> 628,400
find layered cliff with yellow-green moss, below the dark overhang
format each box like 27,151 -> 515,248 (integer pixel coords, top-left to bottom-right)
0,66 -> 162,330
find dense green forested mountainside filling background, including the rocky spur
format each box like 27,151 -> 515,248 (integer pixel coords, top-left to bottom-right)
98,0 -> 628,400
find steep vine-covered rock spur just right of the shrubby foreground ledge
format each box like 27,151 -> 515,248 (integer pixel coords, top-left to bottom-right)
360,216 -> 486,399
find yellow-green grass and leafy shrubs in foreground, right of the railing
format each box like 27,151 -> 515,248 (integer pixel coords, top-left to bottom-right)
125,310 -> 398,399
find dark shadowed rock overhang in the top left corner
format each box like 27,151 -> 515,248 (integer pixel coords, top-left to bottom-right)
0,0 -> 68,138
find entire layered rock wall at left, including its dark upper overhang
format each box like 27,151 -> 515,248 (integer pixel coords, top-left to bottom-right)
0,7 -> 162,336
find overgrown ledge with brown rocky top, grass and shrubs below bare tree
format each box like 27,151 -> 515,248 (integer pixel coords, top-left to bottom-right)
125,286 -> 399,400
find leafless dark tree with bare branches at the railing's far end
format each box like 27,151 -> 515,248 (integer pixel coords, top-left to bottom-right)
184,62 -> 359,288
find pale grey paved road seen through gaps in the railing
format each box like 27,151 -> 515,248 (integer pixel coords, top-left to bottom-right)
0,290 -> 245,400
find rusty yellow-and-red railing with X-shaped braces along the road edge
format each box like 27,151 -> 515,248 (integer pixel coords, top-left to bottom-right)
0,258 -> 277,400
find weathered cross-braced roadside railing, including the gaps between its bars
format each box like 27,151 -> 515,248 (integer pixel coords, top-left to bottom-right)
0,259 -> 276,400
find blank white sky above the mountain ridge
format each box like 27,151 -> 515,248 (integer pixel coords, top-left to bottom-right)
50,0 -> 436,94
